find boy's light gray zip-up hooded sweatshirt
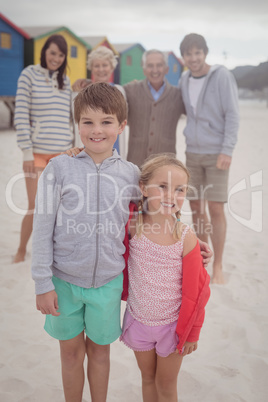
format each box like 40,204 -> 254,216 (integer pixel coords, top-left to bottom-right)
32,150 -> 140,294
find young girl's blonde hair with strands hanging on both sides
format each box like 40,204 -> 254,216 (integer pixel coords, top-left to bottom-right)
136,153 -> 190,240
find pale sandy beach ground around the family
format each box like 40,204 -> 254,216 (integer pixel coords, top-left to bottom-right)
0,101 -> 268,402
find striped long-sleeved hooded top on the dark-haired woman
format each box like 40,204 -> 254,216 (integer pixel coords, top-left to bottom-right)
14,65 -> 73,161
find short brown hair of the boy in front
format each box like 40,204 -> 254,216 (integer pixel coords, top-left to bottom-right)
74,82 -> 127,124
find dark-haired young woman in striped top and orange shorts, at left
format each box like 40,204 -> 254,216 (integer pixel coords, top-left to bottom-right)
14,35 -> 73,262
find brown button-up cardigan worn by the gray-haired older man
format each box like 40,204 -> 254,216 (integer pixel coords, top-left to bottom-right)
124,79 -> 184,166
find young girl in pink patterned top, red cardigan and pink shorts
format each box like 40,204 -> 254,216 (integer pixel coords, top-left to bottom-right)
120,154 -> 210,402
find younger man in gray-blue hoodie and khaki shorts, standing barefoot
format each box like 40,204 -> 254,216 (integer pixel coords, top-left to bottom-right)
179,33 -> 239,284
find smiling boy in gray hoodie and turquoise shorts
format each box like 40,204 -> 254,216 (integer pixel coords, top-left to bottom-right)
32,83 -> 140,402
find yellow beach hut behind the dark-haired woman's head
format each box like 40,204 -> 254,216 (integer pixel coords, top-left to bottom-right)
24,26 -> 91,84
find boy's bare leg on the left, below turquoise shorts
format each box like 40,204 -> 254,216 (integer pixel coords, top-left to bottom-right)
60,332 -> 86,402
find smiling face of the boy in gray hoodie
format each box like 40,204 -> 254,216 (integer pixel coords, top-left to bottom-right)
78,108 -> 127,163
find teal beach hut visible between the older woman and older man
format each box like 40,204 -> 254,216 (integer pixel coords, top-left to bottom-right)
114,43 -> 145,85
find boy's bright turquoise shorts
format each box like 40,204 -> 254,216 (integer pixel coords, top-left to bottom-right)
44,273 -> 123,345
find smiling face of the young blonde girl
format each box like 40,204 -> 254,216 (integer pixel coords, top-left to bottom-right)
140,165 -> 188,215
